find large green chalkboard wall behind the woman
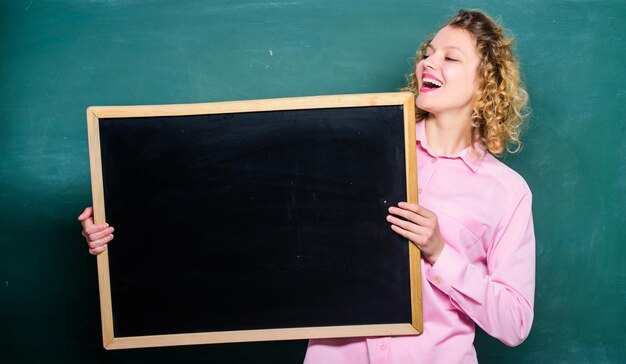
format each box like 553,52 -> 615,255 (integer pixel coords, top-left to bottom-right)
0,0 -> 626,363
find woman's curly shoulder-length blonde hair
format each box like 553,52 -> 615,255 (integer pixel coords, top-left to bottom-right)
402,10 -> 529,155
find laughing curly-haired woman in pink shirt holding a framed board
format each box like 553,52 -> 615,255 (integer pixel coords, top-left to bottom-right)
79,10 -> 535,363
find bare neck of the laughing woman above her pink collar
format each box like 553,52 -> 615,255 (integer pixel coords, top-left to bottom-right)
425,114 -> 472,156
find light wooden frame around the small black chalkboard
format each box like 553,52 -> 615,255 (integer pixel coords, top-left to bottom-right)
87,92 -> 423,349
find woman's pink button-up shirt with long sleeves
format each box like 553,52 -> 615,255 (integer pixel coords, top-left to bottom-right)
304,121 -> 535,364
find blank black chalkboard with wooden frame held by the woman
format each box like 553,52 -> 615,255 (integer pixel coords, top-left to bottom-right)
88,93 -> 421,349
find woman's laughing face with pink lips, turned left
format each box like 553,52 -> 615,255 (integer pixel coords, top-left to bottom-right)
415,26 -> 480,118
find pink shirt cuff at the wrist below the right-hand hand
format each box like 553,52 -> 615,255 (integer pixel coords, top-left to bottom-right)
426,244 -> 468,294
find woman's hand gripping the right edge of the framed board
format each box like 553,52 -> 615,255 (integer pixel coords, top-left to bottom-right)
387,202 -> 446,264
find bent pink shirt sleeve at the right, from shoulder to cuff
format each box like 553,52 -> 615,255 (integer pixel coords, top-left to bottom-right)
426,190 -> 535,346
